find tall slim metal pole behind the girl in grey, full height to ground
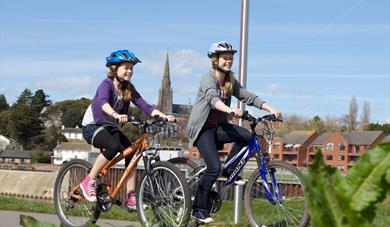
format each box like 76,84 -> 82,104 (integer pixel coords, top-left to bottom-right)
234,0 -> 249,224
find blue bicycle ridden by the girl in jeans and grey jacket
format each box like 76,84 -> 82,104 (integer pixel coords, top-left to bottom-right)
169,112 -> 310,226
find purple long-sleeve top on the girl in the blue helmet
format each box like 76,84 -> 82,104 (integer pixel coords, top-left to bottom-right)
83,78 -> 156,126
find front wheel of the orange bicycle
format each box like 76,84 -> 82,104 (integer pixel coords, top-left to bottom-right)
136,161 -> 191,226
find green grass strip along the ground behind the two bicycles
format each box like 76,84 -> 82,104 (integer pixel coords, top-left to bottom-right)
0,196 -> 390,226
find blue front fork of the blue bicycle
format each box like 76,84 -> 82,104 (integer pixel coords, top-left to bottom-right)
257,156 -> 283,205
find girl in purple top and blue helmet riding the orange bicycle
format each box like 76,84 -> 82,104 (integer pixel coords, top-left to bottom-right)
80,50 -> 175,210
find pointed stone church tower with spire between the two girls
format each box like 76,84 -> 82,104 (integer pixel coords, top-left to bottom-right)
158,53 -> 173,114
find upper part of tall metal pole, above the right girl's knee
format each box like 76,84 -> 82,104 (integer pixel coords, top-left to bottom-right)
237,0 -> 249,126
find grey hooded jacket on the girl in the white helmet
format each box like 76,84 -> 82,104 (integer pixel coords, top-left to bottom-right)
187,71 -> 264,147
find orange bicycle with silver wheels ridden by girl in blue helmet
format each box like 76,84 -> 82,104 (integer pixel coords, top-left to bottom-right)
54,117 -> 191,226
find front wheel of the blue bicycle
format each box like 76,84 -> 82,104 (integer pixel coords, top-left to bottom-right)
244,161 -> 310,226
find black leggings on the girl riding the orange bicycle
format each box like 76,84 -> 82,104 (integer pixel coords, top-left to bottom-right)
93,126 -> 133,166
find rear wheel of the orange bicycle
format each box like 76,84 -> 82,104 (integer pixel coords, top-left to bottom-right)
54,159 -> 100,227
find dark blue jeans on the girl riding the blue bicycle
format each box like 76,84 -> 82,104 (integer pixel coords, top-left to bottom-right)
193,123 -> 252,210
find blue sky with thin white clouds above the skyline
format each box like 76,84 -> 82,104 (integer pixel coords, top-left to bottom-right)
0,0 -> 390,122
